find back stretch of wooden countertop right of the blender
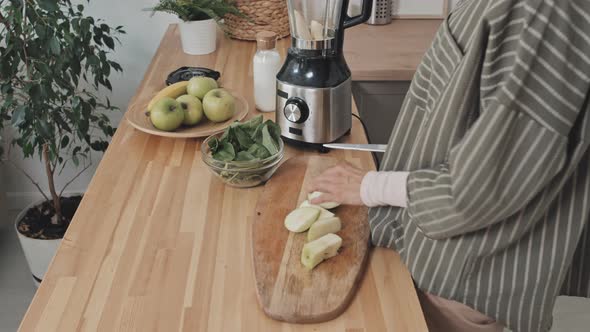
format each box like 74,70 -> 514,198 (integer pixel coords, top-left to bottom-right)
344,20 -> 442,81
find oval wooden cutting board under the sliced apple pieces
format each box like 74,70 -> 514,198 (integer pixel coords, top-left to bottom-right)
252,156 -> 370,323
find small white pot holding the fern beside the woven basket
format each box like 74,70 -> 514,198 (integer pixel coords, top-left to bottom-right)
179,19 -> 217,55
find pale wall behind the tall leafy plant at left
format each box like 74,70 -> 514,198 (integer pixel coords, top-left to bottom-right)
0,0 -> 178,208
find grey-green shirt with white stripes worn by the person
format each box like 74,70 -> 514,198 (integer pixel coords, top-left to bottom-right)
369,0 -> 590,332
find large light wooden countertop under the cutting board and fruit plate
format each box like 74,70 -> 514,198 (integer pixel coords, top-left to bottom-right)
20,26 -> 426,332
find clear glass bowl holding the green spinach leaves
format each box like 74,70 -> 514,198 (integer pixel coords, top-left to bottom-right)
201,134 -> 285,188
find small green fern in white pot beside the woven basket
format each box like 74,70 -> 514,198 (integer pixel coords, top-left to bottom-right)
148,0 -> 244,55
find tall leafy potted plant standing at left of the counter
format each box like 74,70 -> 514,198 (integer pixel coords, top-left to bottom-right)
0,0 -> 125,281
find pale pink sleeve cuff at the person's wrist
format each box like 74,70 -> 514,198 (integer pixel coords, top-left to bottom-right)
361,171 -> 410,208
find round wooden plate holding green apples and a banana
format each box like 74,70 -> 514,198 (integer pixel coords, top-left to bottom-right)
125,91 -> 249,138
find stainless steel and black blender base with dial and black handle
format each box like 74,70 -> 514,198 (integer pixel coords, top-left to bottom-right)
276,0 -> 373,144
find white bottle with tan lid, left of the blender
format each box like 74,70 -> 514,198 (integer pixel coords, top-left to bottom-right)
253,31 -> 281,112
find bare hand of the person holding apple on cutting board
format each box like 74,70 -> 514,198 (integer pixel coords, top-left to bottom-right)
309,163 -> 367,205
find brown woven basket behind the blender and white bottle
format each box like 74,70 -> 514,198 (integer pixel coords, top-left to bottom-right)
224,0 -> 289,40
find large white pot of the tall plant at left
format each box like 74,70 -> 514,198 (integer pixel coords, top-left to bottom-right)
14,194 -> 81,287
